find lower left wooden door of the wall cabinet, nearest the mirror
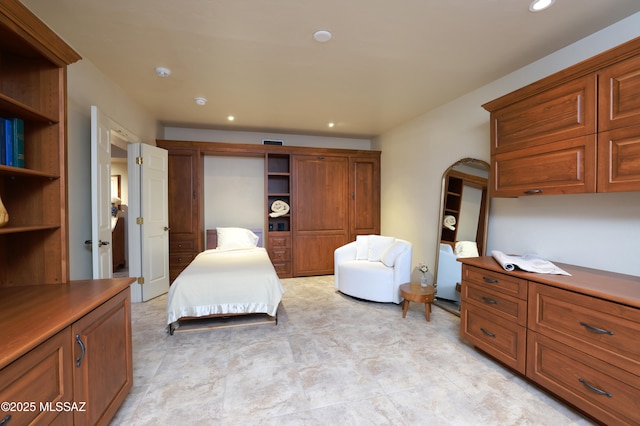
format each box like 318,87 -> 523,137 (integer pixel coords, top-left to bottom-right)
491,135 -> 596,197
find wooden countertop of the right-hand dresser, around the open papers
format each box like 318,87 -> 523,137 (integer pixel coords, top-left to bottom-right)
458,256 -> 640,308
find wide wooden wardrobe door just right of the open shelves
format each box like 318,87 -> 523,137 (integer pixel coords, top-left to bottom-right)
292,155 -> 349,276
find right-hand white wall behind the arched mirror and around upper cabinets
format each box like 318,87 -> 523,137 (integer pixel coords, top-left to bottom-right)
372,13 -> 640,275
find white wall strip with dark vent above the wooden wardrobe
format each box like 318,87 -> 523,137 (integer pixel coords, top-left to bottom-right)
164,127 -> 371,150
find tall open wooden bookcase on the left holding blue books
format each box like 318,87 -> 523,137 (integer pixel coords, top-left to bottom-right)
0,0 -> 80,287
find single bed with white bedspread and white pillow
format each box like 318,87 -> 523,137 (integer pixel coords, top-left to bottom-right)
167,228 -> 284,335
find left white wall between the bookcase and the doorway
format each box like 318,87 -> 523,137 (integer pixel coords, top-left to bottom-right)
67,59 -> 160,280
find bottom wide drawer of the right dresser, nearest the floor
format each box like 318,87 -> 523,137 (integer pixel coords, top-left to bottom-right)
527,331 -> 640,424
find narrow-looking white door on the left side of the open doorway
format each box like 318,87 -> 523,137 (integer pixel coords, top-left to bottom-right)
91,106 -> 113,278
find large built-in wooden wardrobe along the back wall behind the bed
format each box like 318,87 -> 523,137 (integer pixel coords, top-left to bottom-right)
157,140 -> 380,281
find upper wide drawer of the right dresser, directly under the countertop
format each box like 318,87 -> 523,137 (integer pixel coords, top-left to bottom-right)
528,282 -> 640,376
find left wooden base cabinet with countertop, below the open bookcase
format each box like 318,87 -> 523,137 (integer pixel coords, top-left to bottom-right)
0,278 -> 134,426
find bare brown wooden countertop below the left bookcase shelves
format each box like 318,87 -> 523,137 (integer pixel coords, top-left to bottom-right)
0,278 -> 135,368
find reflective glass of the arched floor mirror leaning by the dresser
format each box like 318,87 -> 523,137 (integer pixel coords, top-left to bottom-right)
434,158 -> 489,315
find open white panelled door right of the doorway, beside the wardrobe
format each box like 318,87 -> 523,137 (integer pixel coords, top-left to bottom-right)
128,143 -> 169,301
